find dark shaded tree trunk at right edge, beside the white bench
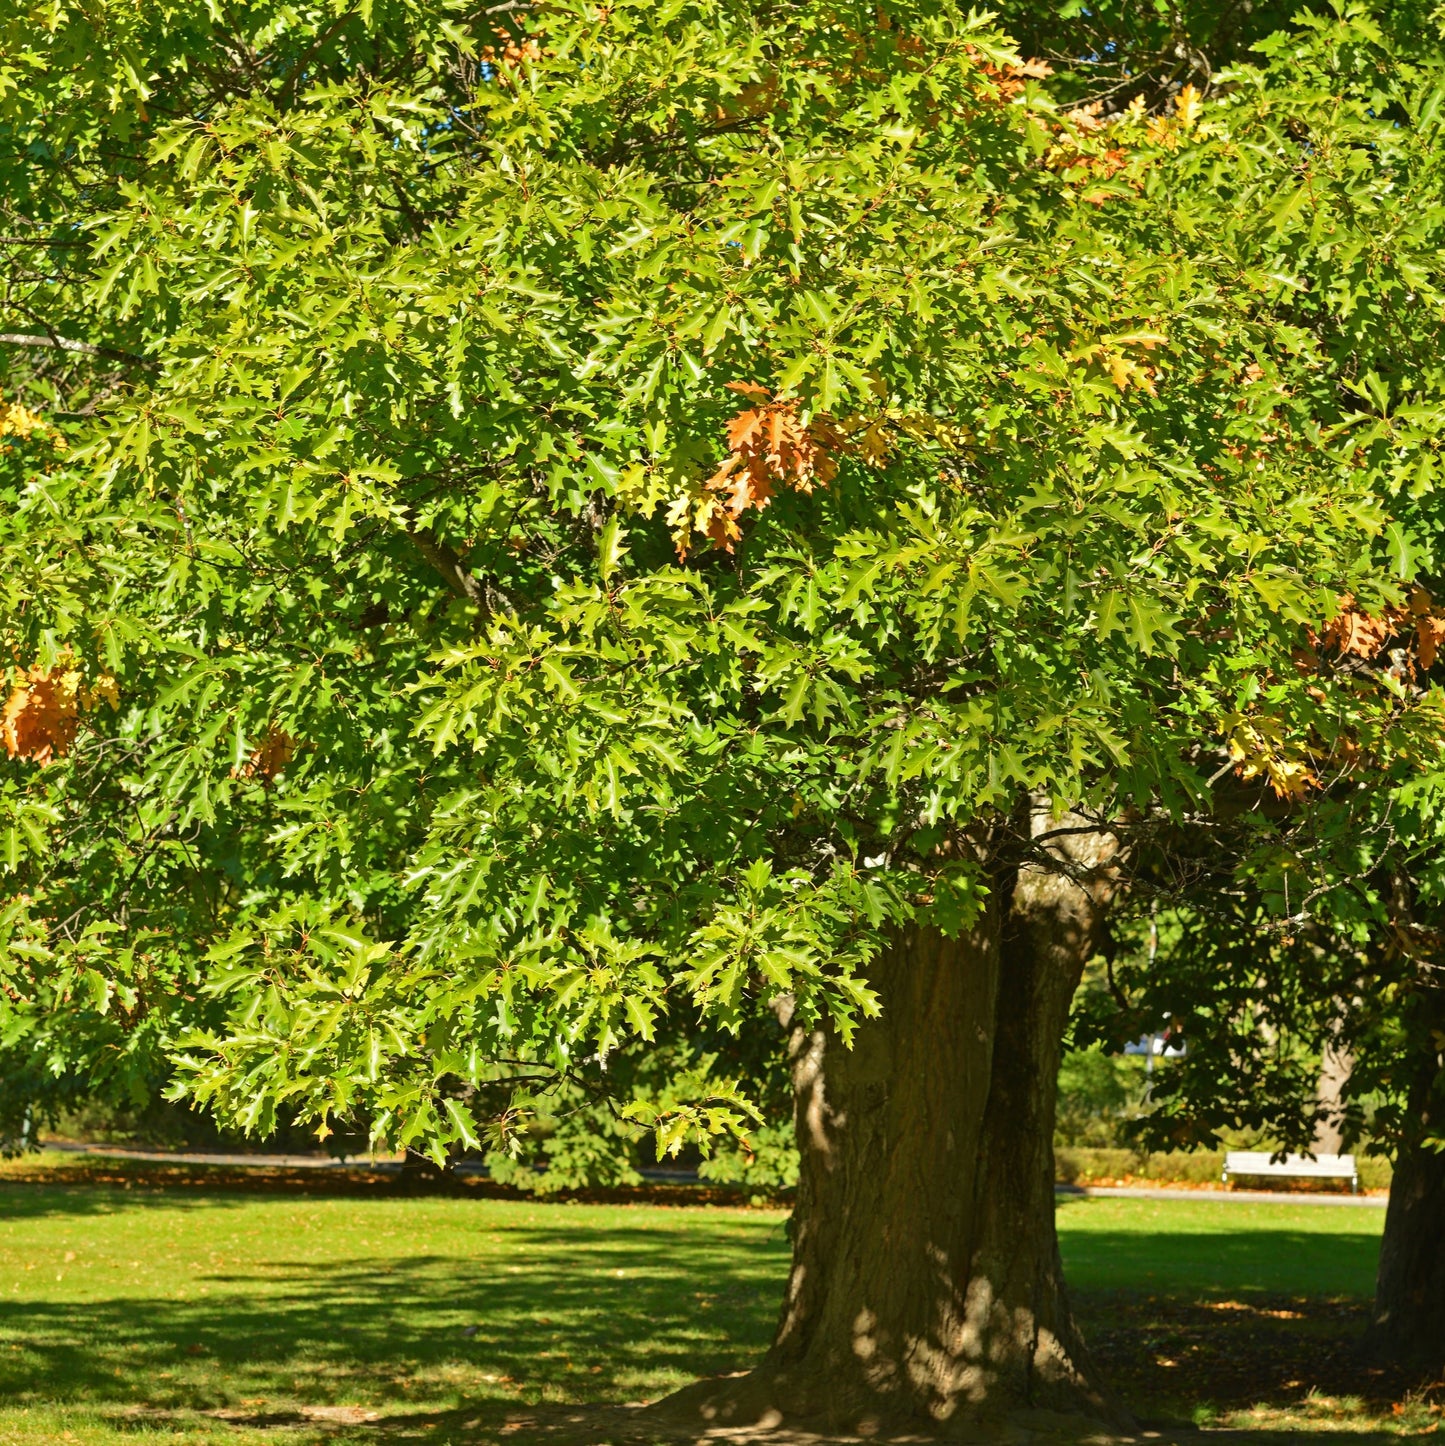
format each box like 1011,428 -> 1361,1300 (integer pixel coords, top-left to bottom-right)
1365,1054 -> 1445,1371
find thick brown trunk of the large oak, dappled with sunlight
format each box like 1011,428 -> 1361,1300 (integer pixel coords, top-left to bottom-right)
673,838 -> 1105,1429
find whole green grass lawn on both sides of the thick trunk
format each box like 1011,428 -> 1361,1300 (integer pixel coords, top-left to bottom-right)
0,1183 -> 1438,1446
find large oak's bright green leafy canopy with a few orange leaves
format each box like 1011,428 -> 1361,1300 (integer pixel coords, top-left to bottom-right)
0,0 -> 1445,1157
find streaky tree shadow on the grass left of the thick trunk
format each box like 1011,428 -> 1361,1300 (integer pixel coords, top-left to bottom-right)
0,1225 -> 787,1410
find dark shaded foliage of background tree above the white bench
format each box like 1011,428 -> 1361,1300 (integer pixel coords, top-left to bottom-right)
1076,884 -> 1445,1155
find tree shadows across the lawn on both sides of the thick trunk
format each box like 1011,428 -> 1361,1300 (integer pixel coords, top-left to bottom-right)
0,1192 -> 1434,1446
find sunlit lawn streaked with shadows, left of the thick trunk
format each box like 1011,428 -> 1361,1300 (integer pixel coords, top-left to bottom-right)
0,1192 -> 787,1408
